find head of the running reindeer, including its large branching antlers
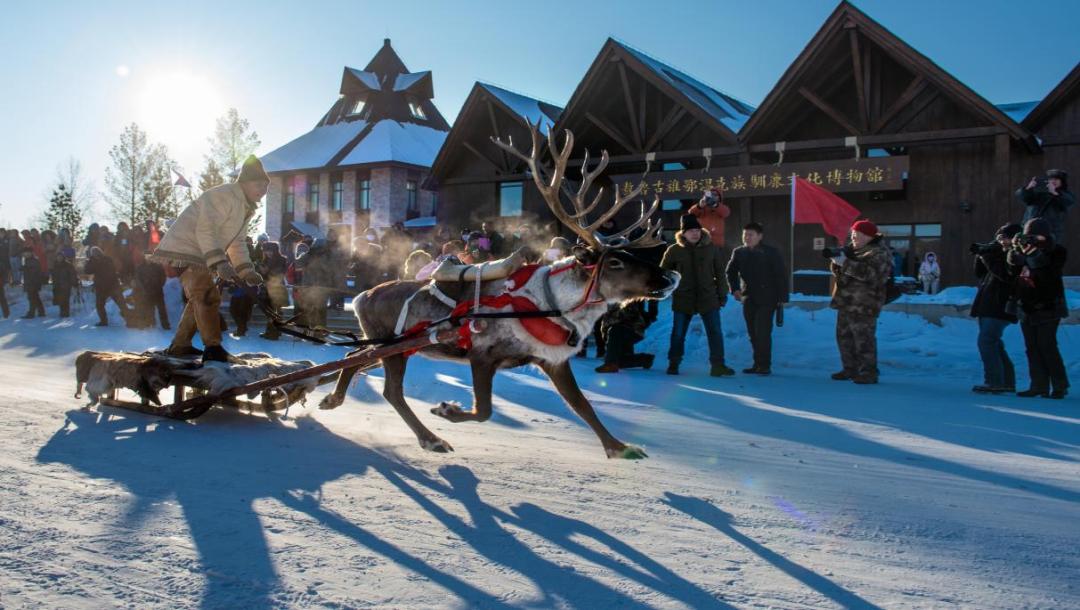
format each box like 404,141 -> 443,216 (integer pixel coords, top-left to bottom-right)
491,119 -> 679,303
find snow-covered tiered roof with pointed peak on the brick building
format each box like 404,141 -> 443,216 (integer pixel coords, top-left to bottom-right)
264,39 -> 449,173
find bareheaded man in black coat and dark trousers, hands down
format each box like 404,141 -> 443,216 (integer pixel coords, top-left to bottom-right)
728,222 -> 787,375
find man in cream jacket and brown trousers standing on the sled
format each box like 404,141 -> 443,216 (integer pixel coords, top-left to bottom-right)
152,154 -> 270,362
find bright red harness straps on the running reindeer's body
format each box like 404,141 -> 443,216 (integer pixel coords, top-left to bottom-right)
403,255 -> 605,356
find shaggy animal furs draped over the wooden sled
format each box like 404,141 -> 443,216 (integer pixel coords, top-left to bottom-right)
75,352 -> 319,406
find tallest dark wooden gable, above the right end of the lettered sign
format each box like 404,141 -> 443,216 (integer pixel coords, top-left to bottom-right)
740,1 -> 1037,149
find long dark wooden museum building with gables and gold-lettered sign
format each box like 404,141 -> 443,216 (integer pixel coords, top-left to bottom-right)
432,1 -> 1080,285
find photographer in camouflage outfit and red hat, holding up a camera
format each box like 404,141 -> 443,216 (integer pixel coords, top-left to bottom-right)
825,220 -> 892,383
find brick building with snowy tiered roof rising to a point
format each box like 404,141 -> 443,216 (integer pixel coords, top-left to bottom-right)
262,39 -> 449,239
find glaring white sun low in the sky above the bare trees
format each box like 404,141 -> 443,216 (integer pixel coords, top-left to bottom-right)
137,71 -> 226,158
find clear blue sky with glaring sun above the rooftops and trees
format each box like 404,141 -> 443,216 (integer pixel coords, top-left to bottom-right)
0,0 -> 1080,226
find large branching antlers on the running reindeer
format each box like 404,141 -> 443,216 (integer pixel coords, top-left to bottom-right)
491,119 -> 662,249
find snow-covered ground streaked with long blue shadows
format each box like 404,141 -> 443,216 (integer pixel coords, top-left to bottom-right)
0,282 -> 1080,609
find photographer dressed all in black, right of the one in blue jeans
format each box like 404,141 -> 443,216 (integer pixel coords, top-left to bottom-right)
1007,218 -> 1069,398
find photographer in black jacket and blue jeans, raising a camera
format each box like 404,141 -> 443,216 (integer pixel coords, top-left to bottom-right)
969,223 -> 1023,394
